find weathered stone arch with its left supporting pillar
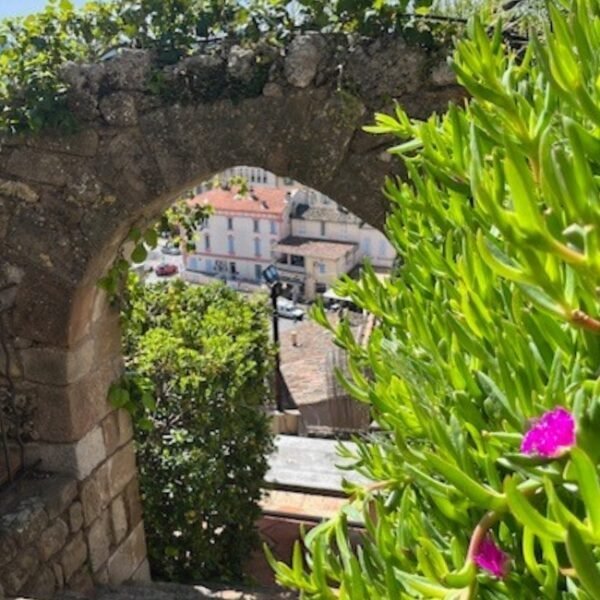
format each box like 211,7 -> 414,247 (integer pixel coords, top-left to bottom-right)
0,34 -> 460,583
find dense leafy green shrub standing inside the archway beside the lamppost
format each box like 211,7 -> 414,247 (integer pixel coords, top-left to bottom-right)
111,280 -> 273,581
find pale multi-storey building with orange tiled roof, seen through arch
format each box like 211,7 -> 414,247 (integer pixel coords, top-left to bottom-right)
185,187 -> 293,282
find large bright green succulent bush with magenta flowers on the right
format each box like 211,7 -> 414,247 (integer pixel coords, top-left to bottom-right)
275,0 -> 600,600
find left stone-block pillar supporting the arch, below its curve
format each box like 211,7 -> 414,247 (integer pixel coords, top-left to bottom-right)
0,274 -> 150,589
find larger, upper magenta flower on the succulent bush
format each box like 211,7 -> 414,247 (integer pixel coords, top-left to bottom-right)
521,406 -> 575,458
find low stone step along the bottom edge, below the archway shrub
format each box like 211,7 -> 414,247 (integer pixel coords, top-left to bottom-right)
55,583 -> 298,600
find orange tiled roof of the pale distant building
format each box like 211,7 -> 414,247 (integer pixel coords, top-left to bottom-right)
189,187 -> 290,216
